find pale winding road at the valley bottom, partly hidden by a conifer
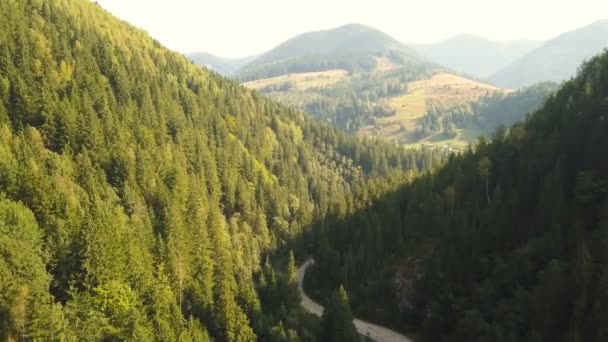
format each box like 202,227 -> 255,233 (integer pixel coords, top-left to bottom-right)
298,259 -> 413,342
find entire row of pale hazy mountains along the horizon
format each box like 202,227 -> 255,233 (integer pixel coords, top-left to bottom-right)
189,20 -> 608,88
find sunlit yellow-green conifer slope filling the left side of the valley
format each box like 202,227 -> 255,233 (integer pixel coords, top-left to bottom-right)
0,0 -> 436,341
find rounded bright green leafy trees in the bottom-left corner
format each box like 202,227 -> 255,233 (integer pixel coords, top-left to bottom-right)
0,197 -> 63,340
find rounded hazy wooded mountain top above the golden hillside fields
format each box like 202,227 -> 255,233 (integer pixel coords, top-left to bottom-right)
235,24 -> 430,81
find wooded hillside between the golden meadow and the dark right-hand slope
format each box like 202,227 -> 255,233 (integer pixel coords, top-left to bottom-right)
419,82 -> 557,137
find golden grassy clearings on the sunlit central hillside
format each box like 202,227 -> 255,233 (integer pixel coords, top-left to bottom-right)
243,69 -> 512,149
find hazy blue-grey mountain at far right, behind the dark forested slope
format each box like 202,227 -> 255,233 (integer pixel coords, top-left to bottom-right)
489,20 -> 608,88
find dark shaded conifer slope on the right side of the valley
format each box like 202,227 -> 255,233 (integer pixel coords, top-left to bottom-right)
307,53 -> 608,342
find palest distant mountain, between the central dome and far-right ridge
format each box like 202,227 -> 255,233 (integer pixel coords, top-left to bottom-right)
410,34 -> 541,79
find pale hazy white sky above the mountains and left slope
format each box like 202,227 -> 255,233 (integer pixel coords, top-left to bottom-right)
98,0 -> 608,57
